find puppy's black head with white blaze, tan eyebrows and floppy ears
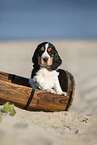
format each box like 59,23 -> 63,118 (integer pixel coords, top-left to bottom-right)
32,42 -> 62,70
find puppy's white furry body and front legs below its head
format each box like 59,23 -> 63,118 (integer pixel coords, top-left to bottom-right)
29,68 -> 66,95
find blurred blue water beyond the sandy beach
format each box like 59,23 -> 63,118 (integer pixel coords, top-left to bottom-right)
0,0 -> 97,40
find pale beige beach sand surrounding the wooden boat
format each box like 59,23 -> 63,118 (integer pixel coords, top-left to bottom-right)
0,40 -> 97,145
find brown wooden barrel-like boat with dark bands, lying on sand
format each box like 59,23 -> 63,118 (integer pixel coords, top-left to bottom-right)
0,71 -> 75,111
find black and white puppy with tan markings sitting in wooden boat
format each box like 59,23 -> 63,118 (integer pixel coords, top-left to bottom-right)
29,42 -> 67,96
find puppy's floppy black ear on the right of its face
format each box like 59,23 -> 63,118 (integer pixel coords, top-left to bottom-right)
51,50 -> 62,70
